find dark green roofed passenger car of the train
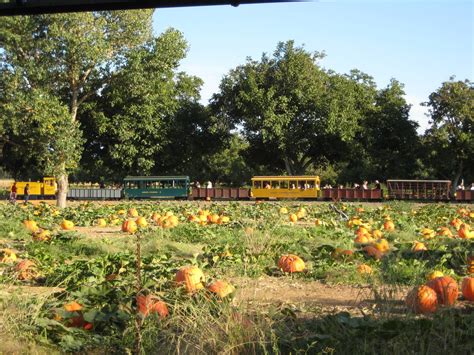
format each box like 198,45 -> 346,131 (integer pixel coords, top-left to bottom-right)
123,176 -> 190,199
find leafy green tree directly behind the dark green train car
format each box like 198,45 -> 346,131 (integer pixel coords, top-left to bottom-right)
81,29 -> 225,180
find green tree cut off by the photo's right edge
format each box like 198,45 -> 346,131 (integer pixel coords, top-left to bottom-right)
424,78 -> 474,188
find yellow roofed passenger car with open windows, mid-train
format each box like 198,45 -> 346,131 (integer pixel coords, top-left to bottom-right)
251,176 -> 320,199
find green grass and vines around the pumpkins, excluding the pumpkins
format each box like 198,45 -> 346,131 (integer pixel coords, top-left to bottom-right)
0,202 -> 474,354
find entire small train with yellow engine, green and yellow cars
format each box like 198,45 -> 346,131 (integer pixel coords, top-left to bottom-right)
8,176 -> 474,203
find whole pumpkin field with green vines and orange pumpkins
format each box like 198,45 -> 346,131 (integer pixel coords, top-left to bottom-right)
0,201 -> 474,354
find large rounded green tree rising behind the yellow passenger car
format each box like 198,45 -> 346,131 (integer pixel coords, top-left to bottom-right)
211,41 -> 375,175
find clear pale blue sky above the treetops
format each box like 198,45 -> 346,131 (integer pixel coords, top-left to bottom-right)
153,0 -> 474,133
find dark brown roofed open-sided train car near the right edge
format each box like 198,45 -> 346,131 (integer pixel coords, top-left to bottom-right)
387,180 -> 451,201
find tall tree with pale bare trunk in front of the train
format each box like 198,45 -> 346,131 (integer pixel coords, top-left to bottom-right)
0,10 -> 152,207
